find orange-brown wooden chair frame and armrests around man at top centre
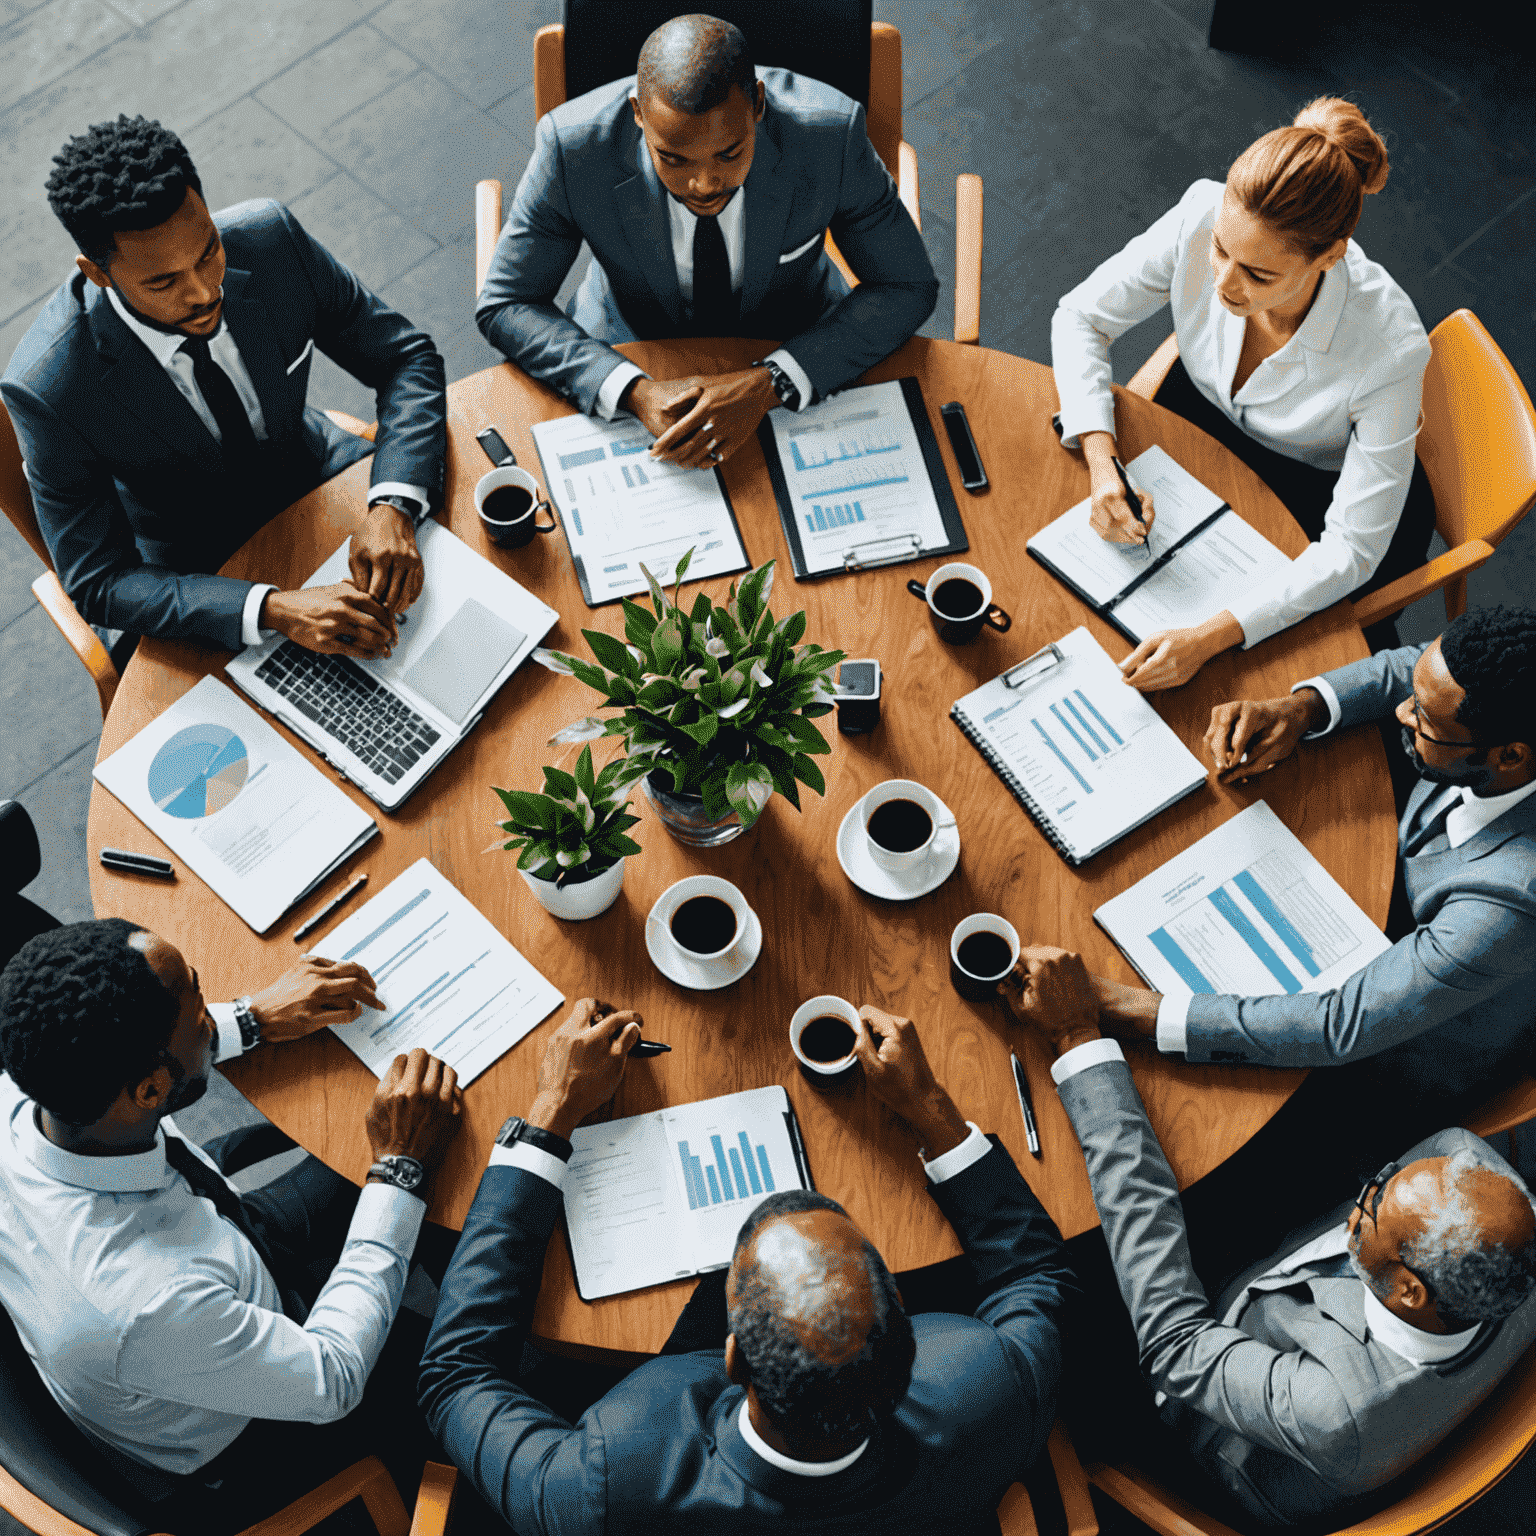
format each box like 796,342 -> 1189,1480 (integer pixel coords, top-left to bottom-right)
475,9 -> 983,346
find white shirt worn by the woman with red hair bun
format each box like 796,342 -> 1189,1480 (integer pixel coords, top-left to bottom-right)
1051,181 -> 1430,647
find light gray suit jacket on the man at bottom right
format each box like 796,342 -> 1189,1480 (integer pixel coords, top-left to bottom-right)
1061,1061 -> 1536,1524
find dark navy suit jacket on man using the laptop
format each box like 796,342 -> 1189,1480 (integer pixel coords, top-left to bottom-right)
0,200 -> 447,650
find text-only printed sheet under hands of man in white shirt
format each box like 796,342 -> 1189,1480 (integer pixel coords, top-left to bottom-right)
324,859 -> 565,1087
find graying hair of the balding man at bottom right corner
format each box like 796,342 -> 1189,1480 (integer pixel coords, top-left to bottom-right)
1401,1147 -> 1536,1329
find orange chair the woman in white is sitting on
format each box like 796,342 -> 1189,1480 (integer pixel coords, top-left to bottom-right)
1126,309 -> 1536,628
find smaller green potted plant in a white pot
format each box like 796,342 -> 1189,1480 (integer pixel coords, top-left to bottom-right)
496,746 -> 641,920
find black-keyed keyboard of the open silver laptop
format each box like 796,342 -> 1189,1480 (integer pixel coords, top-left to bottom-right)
257,641 -> 439,783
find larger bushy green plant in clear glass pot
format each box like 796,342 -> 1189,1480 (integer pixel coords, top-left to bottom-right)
533,550 -> 843,846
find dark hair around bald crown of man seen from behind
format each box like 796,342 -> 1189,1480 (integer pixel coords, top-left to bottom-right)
730,1189 -> 917,1444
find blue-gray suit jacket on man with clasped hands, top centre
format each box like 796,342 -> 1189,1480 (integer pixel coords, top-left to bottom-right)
475,69 -> 938,412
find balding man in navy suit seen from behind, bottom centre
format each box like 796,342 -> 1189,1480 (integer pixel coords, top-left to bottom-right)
421,998 -> 1072,1536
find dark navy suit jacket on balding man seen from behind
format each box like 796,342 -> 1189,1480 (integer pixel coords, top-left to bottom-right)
421,1140 -> 1072,1536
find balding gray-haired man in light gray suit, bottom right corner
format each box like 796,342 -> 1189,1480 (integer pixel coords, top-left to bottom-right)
1001,948 -> 1536,1527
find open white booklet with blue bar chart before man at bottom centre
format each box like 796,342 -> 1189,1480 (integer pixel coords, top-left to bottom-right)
565,1086 -> 811,1301
